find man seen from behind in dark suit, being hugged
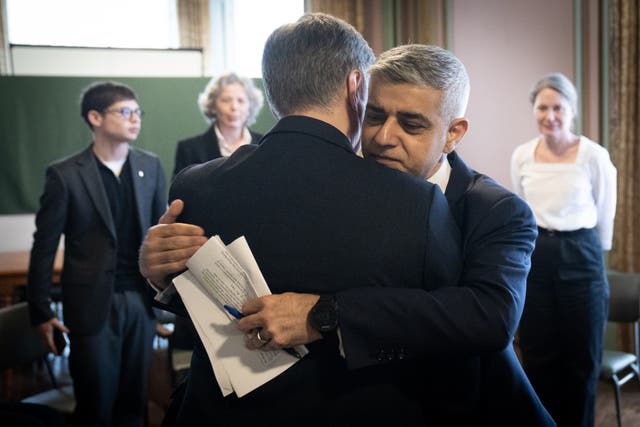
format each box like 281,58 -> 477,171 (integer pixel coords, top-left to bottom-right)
142,14 -> 460,426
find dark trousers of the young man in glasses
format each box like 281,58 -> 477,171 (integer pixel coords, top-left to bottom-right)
69,291 -> 155,427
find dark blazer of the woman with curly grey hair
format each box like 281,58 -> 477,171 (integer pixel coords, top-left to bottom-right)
173,125 -> 262,176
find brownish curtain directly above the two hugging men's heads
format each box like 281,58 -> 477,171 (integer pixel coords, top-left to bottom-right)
305,0 -> 445,55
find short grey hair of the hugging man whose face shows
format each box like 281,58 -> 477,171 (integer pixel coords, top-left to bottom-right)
369,44 -> 470,124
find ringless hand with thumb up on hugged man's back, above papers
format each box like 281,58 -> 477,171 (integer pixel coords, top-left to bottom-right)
138,200 -> 207,289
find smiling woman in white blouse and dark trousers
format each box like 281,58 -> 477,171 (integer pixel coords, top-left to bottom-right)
511,73 -> 616,427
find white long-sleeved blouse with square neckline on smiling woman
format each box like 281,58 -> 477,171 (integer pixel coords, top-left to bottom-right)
511,136 -> 617,250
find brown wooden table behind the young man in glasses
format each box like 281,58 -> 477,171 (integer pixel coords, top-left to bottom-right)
0,250 -> 63,307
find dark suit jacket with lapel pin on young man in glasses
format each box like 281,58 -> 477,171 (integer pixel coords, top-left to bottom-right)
27,146 -> 166,335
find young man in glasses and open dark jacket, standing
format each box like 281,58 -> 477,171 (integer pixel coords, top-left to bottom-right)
27,82 -> 166,426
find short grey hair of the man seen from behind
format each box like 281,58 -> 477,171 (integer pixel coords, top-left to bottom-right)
262,13 -> 375,118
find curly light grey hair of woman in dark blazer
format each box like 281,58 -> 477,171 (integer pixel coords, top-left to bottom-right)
198,73 -> 264,126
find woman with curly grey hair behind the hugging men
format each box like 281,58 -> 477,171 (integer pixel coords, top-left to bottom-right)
173,73 -> 263,176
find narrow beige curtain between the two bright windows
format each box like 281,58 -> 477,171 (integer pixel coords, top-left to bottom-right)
176,0 -> 213,76
